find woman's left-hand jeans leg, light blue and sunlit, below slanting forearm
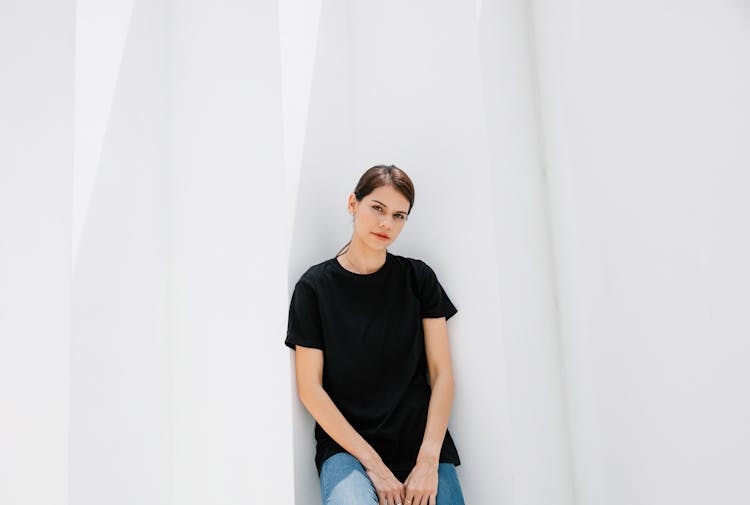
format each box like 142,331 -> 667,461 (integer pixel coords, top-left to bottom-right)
320,452 -> 378,505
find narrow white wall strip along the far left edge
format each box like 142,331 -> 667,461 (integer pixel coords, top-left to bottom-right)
0,1 -> 75,505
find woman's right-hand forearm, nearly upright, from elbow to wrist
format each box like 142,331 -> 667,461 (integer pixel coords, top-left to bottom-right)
417,373 -> 454,464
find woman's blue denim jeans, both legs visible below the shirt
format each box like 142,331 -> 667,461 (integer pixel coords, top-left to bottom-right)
320,452 -> 464,505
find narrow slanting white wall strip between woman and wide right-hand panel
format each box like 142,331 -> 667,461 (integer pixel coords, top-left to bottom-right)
479,0 -> 574,505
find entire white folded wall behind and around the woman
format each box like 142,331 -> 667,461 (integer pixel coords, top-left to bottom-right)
0,0 -> 750,505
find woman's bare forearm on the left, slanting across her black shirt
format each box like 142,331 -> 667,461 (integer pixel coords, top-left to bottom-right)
300,385 -> 383,470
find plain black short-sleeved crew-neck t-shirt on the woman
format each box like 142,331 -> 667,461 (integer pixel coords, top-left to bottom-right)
285,252 -> 460,481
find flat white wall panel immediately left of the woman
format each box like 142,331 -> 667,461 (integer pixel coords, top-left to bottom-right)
170,0 -> 294,505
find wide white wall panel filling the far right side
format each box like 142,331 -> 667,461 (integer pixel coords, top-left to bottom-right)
534,0 -> 750,505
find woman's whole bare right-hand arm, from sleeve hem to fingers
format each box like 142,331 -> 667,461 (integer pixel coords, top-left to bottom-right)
404,317 -> 454,505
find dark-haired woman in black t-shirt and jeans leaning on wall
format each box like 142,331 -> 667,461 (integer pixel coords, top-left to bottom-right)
285,165 -> 464,505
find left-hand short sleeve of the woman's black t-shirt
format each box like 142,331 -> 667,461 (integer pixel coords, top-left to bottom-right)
284,279 -> 325,349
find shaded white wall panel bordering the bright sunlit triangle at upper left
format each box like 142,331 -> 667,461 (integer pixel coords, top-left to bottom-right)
68,1 -> 173,505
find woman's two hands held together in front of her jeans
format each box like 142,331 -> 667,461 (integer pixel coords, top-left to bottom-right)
367,458 -> 439,505
